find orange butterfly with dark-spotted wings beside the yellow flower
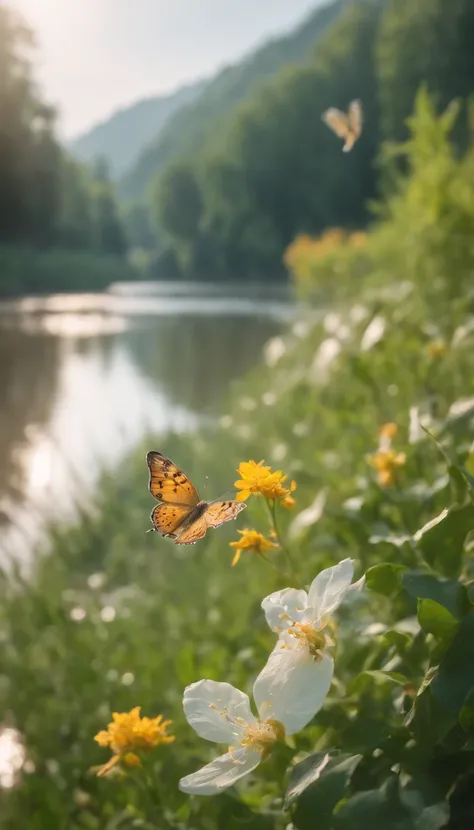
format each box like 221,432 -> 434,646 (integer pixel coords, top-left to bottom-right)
146,451 -> 247,545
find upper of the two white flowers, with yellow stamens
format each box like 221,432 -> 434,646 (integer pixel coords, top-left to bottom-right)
260,559 -> 359,720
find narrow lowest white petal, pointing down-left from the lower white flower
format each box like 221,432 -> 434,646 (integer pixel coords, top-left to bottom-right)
179,748 -> 262,795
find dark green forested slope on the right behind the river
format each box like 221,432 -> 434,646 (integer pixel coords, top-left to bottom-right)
130,0 -> 474,279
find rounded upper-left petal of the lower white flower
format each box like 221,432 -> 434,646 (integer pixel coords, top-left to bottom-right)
183,680 -> 255,746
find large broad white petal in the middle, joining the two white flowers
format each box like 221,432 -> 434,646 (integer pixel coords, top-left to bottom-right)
253,646 -> 334,735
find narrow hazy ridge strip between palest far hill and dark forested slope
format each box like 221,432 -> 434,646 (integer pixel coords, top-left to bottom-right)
118,0 -> 347,200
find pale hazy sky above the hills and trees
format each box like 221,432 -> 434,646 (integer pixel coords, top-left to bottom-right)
12,0 -> 325,137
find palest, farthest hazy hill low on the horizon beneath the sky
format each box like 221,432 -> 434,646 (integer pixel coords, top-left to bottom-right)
68,81 -> 205,179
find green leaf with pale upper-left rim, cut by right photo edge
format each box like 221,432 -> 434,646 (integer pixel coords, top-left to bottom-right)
413,502 -> 474,576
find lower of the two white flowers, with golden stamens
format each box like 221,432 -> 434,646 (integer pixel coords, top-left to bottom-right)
179,672 -> 330,795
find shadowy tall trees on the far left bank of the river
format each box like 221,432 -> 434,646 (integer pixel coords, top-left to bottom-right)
0,5 -> 127,293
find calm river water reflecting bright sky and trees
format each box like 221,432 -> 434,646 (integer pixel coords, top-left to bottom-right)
0,284 -> 293,555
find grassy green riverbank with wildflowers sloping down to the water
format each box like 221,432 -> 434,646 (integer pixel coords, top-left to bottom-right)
0,94 -> 474,830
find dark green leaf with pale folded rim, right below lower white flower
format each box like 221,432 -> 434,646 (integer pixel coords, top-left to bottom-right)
285,752 -> 362,830
